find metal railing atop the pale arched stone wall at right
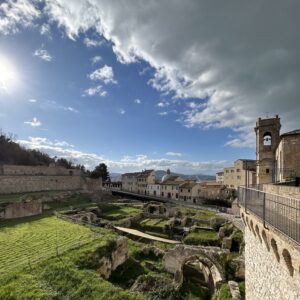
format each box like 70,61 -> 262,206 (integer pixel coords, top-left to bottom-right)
238,187 -> 300,244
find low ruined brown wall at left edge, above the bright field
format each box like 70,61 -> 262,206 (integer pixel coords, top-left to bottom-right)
0,201 -> 43,219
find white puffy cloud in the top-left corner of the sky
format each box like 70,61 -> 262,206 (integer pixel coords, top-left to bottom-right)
0,0 -> 41,35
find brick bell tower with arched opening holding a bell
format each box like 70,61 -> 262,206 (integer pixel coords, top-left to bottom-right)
254,115 -> 281,184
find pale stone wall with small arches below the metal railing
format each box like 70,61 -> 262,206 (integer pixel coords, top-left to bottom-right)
241,210 -> 300,300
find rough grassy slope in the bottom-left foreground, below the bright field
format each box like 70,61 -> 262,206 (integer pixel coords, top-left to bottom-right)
0,234 -> 143,300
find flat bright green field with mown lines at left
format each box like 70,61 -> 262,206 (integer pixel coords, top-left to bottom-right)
0,216 -> 96,274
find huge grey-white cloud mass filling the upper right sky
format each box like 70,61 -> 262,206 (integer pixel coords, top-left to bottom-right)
41,0 -> 300,145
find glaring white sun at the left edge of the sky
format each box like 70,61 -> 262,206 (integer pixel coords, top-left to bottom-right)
0,55 -> 18,92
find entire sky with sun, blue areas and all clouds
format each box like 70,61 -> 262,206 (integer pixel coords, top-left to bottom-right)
0,0 -> 300,174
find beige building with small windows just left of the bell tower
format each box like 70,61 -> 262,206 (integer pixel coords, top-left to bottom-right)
223,159 -> 256,189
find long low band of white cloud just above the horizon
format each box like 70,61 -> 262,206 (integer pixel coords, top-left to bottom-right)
18,137 -> 231,174
